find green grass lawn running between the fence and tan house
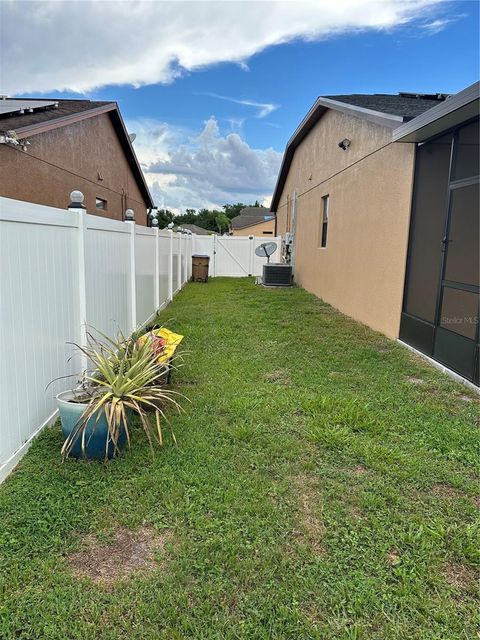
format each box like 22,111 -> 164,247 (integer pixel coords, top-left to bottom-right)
0,278 -> 479,640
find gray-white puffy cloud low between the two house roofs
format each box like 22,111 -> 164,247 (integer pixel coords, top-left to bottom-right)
128,116 -> 282,211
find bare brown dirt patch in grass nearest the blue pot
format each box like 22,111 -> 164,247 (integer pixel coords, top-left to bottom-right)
67,528 -> 172,585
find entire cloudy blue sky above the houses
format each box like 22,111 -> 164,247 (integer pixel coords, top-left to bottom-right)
1,0 -> 479,210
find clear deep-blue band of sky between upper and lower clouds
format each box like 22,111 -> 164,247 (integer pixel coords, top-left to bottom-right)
99,1 -> 479,151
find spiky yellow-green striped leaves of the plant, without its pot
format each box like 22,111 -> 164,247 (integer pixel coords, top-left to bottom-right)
62,333 -> 181,458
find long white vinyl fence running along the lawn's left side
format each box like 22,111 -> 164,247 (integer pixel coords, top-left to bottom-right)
0,197 -> 194,481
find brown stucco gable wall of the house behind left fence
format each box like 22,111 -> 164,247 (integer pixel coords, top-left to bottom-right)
0,112 -> 151,224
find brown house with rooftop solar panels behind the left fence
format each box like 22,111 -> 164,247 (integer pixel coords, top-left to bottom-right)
0,98 -> 153,225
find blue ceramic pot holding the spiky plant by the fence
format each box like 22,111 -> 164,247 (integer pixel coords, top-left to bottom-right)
57,391 -> 127,460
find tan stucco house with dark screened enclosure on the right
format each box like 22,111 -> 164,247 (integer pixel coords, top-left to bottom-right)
271,83 -> 479,384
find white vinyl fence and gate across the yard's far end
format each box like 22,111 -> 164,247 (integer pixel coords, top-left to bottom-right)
193,236 -> 281,278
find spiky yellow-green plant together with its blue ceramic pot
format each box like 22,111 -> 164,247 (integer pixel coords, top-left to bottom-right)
57,333 -> 181,459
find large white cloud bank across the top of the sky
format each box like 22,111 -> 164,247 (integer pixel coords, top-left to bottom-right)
0,0 -> 442,94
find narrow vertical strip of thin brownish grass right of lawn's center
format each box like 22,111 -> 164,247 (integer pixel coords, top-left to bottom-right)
293,475 -> 325,555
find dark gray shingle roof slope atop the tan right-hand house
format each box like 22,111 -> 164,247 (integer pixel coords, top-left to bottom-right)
324,93 -> 447,119
